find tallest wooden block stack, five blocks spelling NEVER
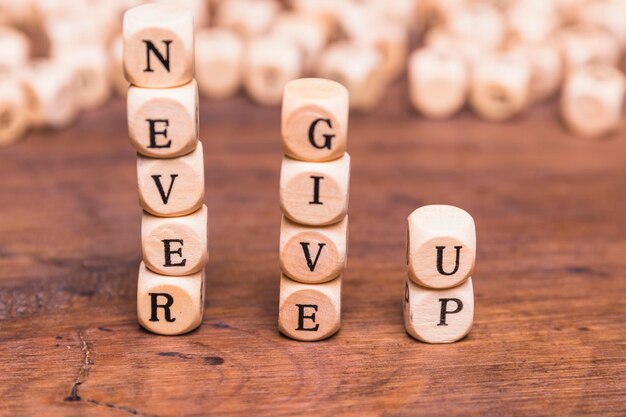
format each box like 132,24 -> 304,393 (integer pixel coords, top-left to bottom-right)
123,4 -> 208,335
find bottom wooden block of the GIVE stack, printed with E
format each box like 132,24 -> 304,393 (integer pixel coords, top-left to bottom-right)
278,275 -> 342,342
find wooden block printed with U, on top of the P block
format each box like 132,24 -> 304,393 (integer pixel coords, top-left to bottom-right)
407,205 -> 476,289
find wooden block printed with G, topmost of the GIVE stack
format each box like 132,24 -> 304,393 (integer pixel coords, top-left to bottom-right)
281,78 -> 349,162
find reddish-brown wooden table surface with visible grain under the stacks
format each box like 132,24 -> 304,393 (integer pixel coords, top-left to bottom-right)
0,86 -> 626,417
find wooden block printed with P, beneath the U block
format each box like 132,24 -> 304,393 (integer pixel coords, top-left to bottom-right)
403,278 -> 474,343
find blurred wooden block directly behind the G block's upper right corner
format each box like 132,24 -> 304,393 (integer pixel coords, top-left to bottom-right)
316,42 -> 387,111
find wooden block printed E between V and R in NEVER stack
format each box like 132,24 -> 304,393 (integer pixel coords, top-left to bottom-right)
141,205 -> 209,276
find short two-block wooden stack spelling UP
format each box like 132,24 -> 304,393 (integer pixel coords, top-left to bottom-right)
403,205 -> 476,343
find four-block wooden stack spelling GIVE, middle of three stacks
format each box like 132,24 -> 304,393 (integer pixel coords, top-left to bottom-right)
278,78 -> 350,341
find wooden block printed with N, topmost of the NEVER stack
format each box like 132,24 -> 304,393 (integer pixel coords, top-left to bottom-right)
123,4 -> 194,88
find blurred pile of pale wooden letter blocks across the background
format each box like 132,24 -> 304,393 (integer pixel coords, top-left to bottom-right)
0,0 -> 626,144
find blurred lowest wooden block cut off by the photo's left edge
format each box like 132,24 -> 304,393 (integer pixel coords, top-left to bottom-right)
0,74 -> 29,146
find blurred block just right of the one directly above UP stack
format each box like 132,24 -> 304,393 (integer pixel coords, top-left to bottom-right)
470,54 -> 531,121
